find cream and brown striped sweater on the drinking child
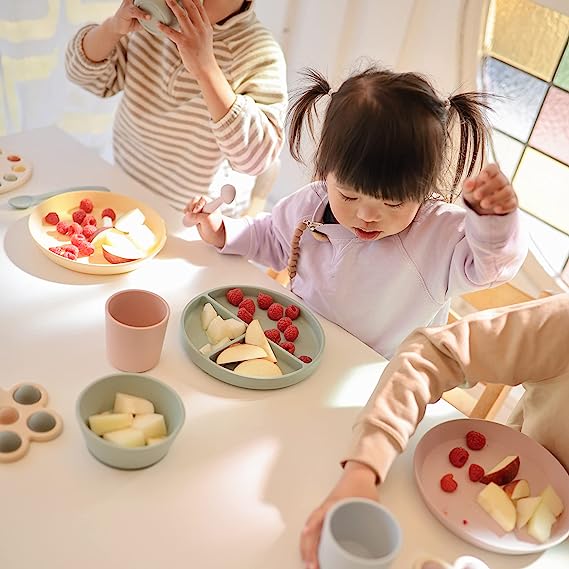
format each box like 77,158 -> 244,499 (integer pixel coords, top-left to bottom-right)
66,3 -> 287,213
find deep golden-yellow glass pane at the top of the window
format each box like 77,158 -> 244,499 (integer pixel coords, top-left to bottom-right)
484,0 -> 569,81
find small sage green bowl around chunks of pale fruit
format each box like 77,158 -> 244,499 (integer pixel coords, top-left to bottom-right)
76,373 -> 186,470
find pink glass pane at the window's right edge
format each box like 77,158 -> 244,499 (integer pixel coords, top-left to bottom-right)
530,87 -> 569,164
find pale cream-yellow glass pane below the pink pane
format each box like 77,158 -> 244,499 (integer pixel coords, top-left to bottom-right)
514,148 -> 569,233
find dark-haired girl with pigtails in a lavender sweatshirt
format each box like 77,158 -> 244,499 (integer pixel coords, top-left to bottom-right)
185,67 -> 527,358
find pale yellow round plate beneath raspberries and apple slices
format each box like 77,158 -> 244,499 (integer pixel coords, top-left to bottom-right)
28,191 -> 166,275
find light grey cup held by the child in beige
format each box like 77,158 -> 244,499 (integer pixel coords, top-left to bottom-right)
318,498 -> 401,569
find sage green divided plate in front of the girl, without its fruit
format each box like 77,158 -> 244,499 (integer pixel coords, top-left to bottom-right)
182,285 -> 325,389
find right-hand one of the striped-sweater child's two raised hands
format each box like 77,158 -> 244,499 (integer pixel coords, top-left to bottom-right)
158,0 -> 216,76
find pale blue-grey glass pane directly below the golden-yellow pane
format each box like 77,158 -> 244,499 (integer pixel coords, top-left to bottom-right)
482,57 -> 547,142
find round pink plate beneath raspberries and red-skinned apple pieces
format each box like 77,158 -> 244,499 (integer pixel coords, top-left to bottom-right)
414,419 -> 569,555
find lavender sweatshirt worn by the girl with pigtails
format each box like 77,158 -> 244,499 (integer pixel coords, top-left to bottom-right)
220,182 -> 527,358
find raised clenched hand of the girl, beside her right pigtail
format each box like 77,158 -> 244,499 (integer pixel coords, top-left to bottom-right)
462,164 -> 518,215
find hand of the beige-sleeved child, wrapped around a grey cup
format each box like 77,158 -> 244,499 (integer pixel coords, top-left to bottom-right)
300,462 -> 378,569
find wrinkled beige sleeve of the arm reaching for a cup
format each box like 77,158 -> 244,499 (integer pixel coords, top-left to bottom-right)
343,294 -> 569,480
